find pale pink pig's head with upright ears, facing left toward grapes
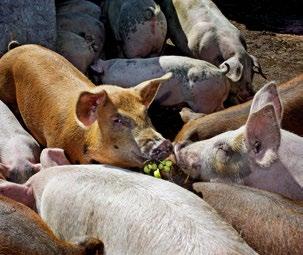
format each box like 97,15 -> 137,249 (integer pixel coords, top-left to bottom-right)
175,80 -> 282,183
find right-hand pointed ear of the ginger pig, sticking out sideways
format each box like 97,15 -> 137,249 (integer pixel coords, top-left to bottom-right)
135,73 -> 172,107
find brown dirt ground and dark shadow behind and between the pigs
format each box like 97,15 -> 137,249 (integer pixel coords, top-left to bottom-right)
150,0 -> 303,139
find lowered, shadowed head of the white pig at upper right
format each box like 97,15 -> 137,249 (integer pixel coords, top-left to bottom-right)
220,50 -> 265,104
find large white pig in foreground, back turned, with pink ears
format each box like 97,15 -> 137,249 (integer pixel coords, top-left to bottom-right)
0,148 -> 256,255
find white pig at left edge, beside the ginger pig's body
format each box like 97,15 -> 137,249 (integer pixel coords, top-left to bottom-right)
0,101 -> 41,183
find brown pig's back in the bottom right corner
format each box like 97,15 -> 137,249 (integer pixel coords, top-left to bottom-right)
193,182 -> 303,255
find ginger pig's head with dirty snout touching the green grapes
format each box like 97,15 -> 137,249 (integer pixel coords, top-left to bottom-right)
76,73 -> 172,167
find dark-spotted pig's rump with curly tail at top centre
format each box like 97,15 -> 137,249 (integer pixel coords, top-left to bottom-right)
104,0 -> 167,58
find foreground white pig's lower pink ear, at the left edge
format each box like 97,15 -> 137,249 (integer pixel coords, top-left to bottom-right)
0,180 -> 36,210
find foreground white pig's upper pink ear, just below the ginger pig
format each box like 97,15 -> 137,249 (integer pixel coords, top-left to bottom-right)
40,148 -> 70,169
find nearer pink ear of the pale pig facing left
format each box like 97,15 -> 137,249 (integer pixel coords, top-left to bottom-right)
244,104 -> 281,167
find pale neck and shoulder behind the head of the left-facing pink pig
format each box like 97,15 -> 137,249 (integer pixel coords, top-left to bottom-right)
244,130 -> 303,200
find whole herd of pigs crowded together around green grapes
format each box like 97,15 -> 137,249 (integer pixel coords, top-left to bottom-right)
0,0 -> 303,255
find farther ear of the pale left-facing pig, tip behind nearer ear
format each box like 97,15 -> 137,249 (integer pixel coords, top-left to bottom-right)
250,81 -> 283,123
